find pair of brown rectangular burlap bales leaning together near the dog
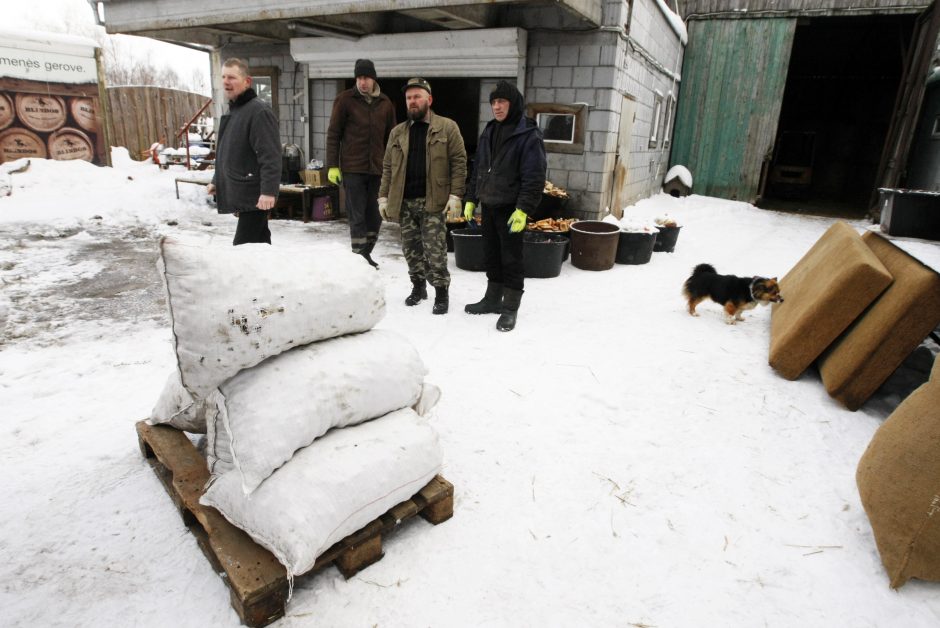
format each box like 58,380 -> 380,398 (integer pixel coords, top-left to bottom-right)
769,222 -> 940,410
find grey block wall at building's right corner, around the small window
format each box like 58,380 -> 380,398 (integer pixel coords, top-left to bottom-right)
524,0 -> 683,218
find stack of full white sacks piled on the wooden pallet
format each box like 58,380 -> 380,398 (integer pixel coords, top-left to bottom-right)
149,237 -> 442,577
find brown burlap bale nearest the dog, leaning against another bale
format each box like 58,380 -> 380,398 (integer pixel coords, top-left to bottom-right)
769,222 -> 891,379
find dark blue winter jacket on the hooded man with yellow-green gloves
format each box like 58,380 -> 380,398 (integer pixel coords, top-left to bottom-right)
464,97 -> 546,214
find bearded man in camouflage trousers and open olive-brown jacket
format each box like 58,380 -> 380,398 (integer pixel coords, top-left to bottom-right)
379,78 -> 467,314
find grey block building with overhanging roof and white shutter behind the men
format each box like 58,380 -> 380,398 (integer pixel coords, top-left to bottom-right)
103,0 -> 687,218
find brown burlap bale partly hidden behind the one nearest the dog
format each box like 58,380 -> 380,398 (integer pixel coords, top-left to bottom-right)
818,231 -> 940,410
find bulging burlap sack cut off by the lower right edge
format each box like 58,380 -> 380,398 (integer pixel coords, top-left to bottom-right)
855,360 -> 940,588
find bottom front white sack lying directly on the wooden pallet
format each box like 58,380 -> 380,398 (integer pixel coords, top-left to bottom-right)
199,408 -> 442,577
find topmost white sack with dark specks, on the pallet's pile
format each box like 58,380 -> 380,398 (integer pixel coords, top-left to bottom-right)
150,237 -> 385,430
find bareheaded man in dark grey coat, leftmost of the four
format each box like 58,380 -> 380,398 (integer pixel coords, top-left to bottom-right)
207,59 -> 281,245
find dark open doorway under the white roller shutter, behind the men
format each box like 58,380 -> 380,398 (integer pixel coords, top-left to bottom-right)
346,77 -> 480,156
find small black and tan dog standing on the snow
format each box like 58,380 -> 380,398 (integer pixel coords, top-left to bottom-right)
682,264 -> 783,325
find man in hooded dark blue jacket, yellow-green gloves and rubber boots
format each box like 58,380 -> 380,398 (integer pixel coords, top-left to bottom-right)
464,81 -> 545,331
